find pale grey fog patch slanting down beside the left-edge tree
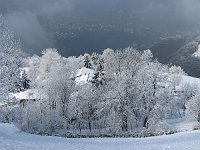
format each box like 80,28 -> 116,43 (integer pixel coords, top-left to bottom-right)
6,11 -> 54,53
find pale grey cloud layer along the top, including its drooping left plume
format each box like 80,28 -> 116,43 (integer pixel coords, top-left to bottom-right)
0,0 -> 200,53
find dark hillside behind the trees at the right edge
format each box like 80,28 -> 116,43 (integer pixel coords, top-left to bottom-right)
150,37 -> 200,77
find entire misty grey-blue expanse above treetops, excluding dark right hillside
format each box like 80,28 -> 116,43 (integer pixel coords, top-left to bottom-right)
0,0 -> 200,55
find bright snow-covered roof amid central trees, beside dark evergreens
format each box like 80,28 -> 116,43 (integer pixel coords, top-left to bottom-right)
75,67 -> 94,85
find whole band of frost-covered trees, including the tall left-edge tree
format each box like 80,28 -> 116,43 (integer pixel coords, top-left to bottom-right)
0,16 -> 200,137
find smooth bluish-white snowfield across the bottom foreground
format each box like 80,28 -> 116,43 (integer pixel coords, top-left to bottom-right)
0,124 -> 200,150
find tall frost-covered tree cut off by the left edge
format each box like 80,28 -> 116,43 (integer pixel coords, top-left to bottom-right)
0,15 -> 23,99
